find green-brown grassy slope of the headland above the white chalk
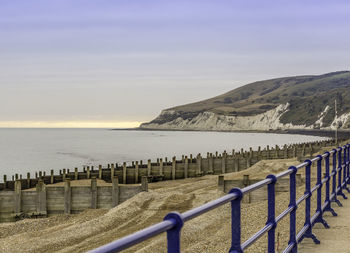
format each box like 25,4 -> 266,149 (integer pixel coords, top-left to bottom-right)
144,71 -> 350,126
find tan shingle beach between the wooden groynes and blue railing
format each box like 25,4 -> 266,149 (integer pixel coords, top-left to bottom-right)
0,141 -> 348,253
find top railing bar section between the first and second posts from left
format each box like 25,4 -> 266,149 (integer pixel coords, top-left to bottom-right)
182,193 -> 238,221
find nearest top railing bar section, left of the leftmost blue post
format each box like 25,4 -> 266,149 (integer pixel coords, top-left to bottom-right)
90,220 -> 175,253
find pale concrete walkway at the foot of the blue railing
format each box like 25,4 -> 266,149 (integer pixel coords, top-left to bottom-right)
298,198 -> 350,253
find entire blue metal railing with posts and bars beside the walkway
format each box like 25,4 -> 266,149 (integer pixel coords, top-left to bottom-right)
91,144 -> 350,253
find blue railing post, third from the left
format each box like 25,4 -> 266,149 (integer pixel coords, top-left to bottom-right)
266,175 -> 277,253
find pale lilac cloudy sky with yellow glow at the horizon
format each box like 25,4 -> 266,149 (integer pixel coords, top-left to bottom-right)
0,0 -> 350,128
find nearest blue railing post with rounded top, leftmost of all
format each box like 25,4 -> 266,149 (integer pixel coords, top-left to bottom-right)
164,212 -> 184,253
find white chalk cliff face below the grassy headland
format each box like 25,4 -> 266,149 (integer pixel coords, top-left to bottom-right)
140,103 -> 350,131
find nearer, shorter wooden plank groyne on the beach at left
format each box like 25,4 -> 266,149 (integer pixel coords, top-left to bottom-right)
0,177 -> 148,222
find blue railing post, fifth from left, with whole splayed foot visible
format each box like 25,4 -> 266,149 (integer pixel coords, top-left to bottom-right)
298,159 -> 320,244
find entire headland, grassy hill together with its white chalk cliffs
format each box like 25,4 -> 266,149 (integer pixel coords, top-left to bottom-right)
140,72 -> 350,131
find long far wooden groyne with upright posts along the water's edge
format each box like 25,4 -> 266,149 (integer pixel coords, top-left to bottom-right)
0,140 -> 335,191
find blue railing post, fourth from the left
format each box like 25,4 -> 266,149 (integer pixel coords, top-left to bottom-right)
288,166 -> 298,253
